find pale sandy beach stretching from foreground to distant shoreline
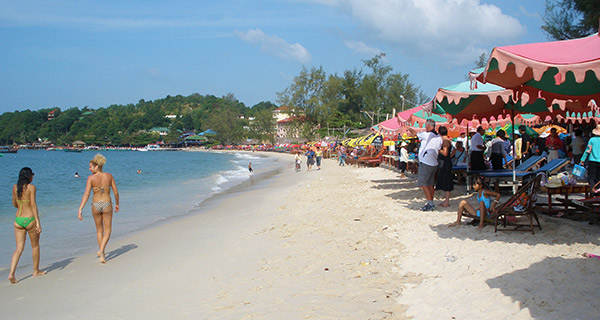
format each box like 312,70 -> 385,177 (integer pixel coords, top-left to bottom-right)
0,154 -> 600,319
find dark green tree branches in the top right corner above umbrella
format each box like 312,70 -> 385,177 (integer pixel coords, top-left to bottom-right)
542,0 -> 600,40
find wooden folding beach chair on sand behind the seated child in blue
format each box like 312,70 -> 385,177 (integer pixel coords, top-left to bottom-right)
493,172 -> 545,234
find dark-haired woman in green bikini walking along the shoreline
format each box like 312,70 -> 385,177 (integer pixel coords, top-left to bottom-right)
8,167 -> 46,284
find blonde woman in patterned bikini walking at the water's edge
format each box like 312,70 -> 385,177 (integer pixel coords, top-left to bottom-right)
78,154 -> 119,263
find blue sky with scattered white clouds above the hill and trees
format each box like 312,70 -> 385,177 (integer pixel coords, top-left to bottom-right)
0,0 -> 547,113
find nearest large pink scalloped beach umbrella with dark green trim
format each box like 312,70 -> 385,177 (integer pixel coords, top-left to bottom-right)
478,33 -> 600,112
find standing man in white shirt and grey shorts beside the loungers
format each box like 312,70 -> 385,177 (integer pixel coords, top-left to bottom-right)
417,119 -> 442,211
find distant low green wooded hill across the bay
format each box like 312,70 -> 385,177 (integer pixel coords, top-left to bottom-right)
0,93 -> 277,145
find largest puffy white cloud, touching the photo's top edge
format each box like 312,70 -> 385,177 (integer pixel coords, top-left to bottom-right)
306,0 -> 525,65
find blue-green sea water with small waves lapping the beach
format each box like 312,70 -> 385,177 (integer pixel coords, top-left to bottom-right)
0,150 -> 276,274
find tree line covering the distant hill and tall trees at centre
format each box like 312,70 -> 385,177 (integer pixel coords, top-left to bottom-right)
0,54 -> 427,146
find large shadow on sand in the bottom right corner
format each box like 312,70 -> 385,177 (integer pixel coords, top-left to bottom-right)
486,257 -> 600,319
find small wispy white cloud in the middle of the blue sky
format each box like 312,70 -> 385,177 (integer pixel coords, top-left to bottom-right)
235,29 -> 311,64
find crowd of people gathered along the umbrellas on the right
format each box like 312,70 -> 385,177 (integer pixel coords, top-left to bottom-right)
297,119 -> 600,227
